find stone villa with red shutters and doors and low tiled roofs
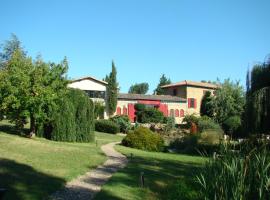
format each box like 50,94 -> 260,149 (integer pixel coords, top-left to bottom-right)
68,76 -> 218,124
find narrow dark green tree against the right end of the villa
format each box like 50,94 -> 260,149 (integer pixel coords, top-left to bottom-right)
200,91 -> 214,117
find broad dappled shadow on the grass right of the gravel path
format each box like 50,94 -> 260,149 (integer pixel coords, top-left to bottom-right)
95,156 -> 200,200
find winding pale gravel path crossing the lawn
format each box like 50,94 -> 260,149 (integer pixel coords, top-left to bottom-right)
50,142 -> 127,200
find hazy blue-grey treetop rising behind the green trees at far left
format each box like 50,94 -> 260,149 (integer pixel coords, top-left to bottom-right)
0,34 -> 26,69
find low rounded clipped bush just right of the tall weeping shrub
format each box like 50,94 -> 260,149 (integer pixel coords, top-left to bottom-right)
95,119 -> 120,134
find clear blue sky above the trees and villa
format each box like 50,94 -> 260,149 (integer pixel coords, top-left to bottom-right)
0,0 -> 270,93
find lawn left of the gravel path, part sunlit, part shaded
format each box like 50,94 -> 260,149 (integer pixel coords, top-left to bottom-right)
0,121 -> 122,200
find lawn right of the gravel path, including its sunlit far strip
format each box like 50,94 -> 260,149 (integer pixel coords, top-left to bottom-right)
95,145 -> 205,200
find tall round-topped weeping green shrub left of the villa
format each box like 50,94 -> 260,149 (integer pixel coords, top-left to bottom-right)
38,89 -> 94,142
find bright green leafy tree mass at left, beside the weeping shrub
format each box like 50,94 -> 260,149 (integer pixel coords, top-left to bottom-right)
0,37 -> 68,133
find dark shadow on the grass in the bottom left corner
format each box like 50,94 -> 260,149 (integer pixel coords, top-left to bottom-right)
0,159 -> 65,200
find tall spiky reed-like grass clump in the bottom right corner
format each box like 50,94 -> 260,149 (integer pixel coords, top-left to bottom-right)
197,143 -> 270,200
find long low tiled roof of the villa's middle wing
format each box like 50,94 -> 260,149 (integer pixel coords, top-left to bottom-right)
117,93 -> 186,102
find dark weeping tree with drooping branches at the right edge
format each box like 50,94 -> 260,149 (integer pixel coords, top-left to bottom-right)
245,60 -> 270,133
